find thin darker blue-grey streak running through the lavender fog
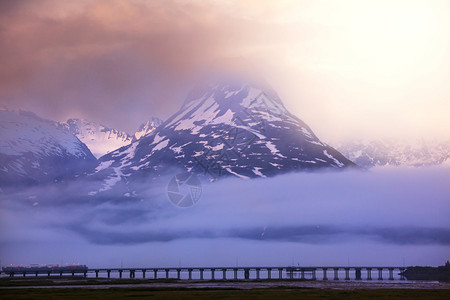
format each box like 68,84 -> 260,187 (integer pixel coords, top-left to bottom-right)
67,224 -> 450,246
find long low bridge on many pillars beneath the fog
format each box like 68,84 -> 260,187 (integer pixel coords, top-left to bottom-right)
0,266 -> 406,280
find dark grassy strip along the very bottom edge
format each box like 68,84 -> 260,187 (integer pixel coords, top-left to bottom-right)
0,288 -> 450,300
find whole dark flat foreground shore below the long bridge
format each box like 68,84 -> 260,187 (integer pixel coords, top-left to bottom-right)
0,278 -> 450,300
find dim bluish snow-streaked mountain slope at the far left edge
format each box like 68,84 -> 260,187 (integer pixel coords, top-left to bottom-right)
0,110 -> 96,187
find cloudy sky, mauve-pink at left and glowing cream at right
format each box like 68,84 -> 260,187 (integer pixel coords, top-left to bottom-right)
0,0 -> 450,143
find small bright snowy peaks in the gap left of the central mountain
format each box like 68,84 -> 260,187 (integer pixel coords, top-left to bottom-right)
61,118 -> 162,158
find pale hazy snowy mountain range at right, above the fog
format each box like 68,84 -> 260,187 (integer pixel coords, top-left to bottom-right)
337,140 -> 450,168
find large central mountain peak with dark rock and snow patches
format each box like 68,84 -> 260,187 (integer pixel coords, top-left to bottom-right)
89,77 -> 355,195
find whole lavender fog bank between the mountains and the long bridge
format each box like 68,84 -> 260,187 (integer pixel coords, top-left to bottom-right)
0,167 -> 450,267
